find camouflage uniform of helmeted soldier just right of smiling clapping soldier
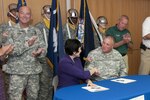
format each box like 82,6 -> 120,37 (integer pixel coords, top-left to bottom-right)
35,22 -> 53,100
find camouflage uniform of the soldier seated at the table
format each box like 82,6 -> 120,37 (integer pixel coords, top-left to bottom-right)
85,47 -> 128,81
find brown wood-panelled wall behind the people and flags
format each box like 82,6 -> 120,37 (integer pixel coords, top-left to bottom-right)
0,0 -> 150,74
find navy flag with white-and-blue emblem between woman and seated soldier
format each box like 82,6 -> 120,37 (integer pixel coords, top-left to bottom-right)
77,0 -> 95,66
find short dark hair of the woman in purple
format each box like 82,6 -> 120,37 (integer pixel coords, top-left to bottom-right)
65,39 -> 81,55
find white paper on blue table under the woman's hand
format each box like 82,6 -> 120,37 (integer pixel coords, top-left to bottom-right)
82,85 -> 109,92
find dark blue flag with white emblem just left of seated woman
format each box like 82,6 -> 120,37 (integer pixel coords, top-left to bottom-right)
47,0 -> 64,75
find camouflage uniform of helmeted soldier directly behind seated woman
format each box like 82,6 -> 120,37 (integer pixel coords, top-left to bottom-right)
63,23 -> 77,42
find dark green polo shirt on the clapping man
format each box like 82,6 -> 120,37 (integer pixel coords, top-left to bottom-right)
106,26 -> 130,55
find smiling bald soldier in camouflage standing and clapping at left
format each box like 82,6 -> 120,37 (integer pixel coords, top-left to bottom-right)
3,6 -> 46,100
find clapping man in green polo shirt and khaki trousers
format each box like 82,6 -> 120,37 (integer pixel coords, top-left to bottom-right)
106,15 -> 132,66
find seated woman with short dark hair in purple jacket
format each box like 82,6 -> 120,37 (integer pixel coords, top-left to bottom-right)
57,39 -> 97,89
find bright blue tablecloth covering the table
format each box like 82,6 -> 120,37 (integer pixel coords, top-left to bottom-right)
54,75 -> 150,100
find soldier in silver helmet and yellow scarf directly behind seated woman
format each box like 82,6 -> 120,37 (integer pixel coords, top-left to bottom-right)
63,8 -> 78,42
